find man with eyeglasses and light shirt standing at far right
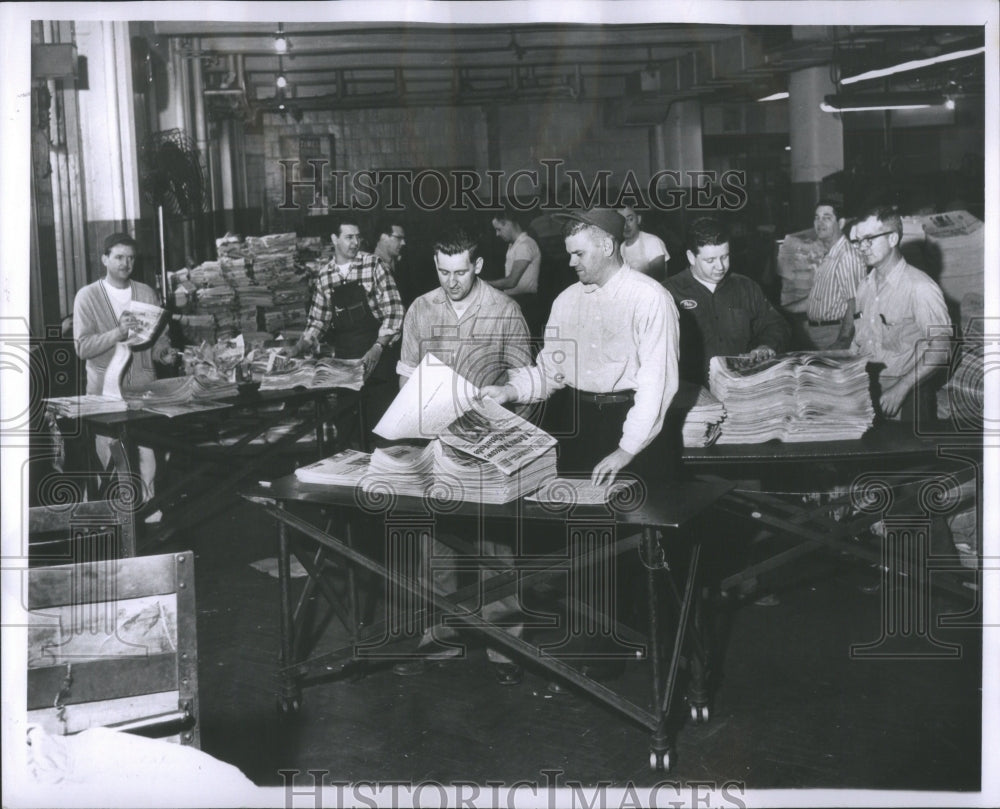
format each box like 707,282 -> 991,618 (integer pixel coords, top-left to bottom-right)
851,206 -> 951,421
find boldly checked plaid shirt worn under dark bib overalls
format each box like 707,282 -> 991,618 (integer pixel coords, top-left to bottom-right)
302,253 -> 404,345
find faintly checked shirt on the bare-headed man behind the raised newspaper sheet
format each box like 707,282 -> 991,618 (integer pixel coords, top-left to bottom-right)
396,280 -> 531,388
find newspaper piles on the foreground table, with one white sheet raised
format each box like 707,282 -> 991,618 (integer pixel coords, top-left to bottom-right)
295,354 -> 556,503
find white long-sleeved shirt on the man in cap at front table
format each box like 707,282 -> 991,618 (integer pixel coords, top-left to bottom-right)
510,265 -> 678,455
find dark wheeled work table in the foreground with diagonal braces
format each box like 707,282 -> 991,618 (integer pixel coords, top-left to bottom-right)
240,475 -> 732,770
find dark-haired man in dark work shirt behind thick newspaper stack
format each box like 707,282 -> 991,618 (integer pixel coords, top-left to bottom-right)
664,216 -> 789,385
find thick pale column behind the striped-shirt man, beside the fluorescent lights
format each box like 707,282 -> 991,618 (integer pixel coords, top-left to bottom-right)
788,65 -> 844,230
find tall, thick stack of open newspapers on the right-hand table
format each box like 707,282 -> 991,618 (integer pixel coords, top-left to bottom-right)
708,351 -> 875,444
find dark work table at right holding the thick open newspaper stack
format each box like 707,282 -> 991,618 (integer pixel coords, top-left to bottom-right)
683,422 -> 983,597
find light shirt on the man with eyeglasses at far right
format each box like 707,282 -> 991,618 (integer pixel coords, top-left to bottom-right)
853,257 -> 951,388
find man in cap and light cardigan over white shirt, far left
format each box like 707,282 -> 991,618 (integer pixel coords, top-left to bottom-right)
73,233 -> 177,522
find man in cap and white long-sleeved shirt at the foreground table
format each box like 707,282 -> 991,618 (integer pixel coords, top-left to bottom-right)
483,208 -> 678,485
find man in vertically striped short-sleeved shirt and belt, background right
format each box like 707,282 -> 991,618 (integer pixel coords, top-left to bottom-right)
805,199 -> 867,349
